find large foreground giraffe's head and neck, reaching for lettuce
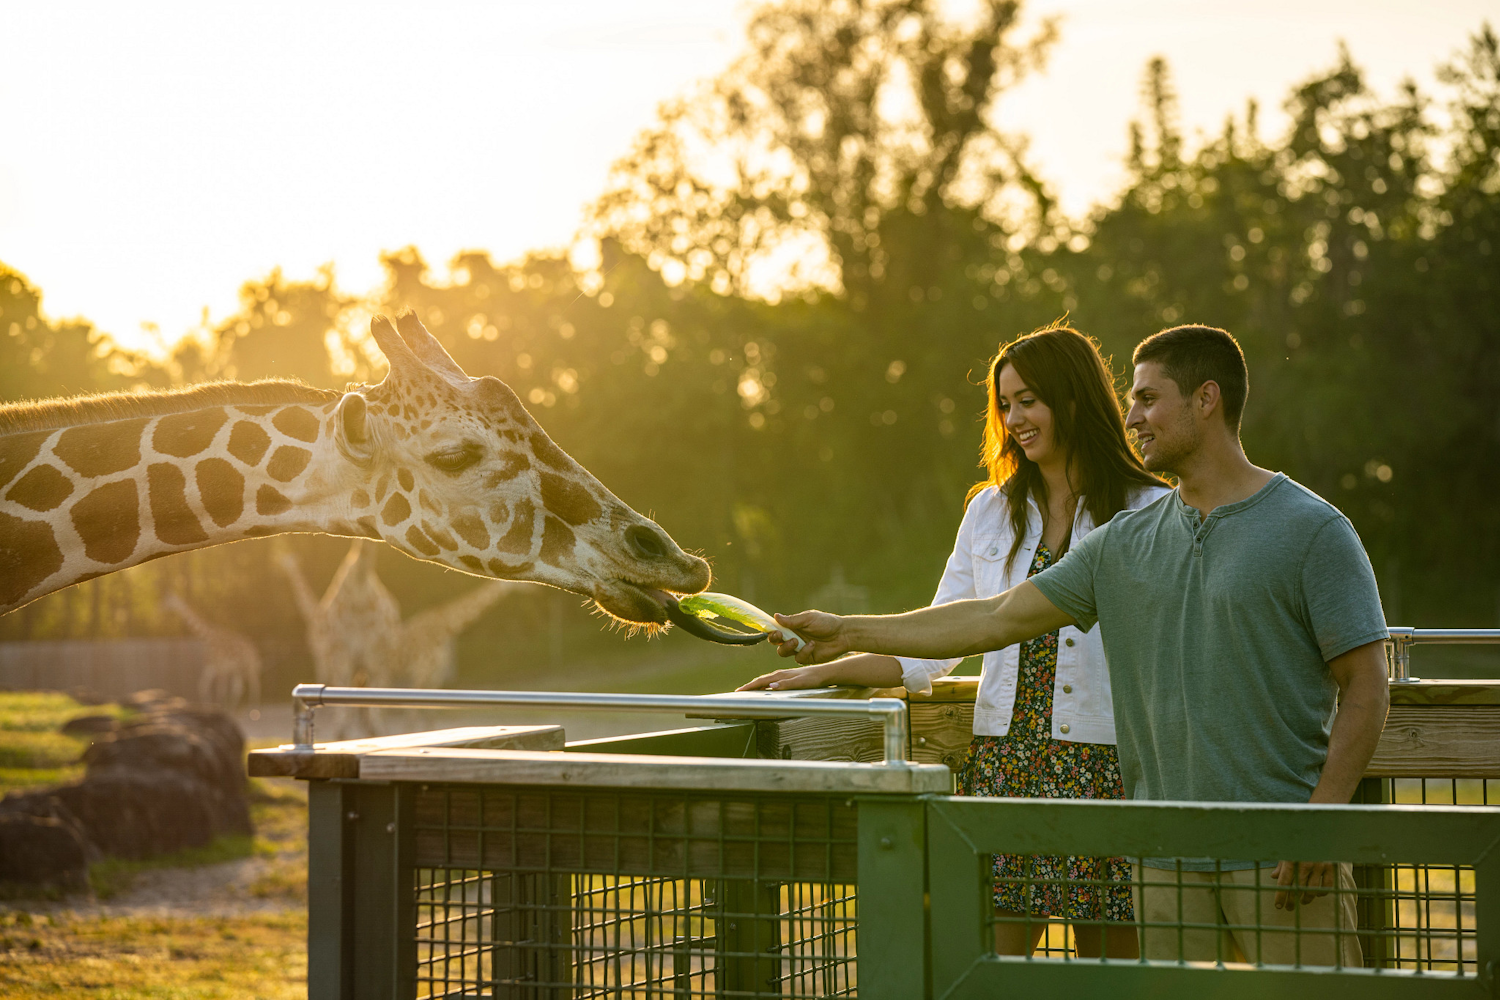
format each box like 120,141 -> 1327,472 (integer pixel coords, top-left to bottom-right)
0,313 -> 710,630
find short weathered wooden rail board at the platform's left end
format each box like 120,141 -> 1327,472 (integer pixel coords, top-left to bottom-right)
248,726 -> 567,778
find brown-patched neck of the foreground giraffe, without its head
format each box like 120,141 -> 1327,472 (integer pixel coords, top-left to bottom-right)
0,384 -> 363,613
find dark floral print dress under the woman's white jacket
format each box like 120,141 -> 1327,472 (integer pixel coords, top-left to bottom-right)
959,544 -> 1134,921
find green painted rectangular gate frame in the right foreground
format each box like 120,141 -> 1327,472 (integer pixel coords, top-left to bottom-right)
924,796 -> 1500,1000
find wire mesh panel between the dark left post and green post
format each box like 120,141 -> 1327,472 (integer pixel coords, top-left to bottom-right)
413,786 -> 858,1000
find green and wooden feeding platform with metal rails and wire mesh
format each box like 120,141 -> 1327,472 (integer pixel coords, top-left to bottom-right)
251,630 -> 1500,1000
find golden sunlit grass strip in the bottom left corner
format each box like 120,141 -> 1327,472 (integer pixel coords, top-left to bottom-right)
0,910 -> 308,1000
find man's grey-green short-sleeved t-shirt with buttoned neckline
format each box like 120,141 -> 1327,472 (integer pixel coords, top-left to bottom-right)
1031,474 -> 1388,802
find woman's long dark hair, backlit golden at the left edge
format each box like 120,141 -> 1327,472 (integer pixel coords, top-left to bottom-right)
966,322 -> 1164,573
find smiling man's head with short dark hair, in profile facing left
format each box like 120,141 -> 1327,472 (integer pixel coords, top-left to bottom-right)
1125,325 -> 1250,472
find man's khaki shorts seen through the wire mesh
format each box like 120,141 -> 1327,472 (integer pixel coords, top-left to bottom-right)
1134,865 -> 1364,969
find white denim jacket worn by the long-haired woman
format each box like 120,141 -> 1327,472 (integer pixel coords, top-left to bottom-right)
897,486 -> 1172,744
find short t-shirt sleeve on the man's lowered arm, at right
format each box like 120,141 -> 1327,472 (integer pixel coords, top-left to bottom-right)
1302,517 -> 1389,663
